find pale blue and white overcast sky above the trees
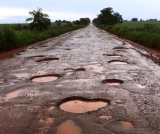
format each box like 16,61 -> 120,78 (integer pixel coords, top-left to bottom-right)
0,0 -> 160,23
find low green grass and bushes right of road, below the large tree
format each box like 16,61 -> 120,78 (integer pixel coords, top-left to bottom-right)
96,25 -> 160,50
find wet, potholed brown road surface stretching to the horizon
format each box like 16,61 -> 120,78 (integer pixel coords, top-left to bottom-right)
0,25 -> 160,134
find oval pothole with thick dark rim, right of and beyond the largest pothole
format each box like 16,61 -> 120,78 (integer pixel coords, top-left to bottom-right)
102,79 -> 124,85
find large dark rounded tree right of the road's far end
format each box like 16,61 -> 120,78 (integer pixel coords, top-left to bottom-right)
93,7 -> 123,25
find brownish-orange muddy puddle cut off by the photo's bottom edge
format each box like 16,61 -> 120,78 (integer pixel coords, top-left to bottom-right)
56,120 -> 82,134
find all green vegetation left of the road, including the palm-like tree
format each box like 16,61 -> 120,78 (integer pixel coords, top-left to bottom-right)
0,8 -> 89,52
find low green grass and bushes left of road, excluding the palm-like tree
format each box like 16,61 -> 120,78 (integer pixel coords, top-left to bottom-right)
0,25 -> 85,52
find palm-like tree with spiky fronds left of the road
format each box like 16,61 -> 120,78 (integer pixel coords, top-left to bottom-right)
26,8 -> 51,31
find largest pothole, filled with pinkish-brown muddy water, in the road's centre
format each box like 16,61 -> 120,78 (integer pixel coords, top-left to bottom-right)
60,98 -> 108,113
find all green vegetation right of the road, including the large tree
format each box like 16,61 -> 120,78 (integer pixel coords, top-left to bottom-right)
93,8 -> 160,50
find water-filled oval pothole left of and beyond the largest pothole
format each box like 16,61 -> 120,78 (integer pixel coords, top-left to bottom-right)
31,75 -> 59,82
